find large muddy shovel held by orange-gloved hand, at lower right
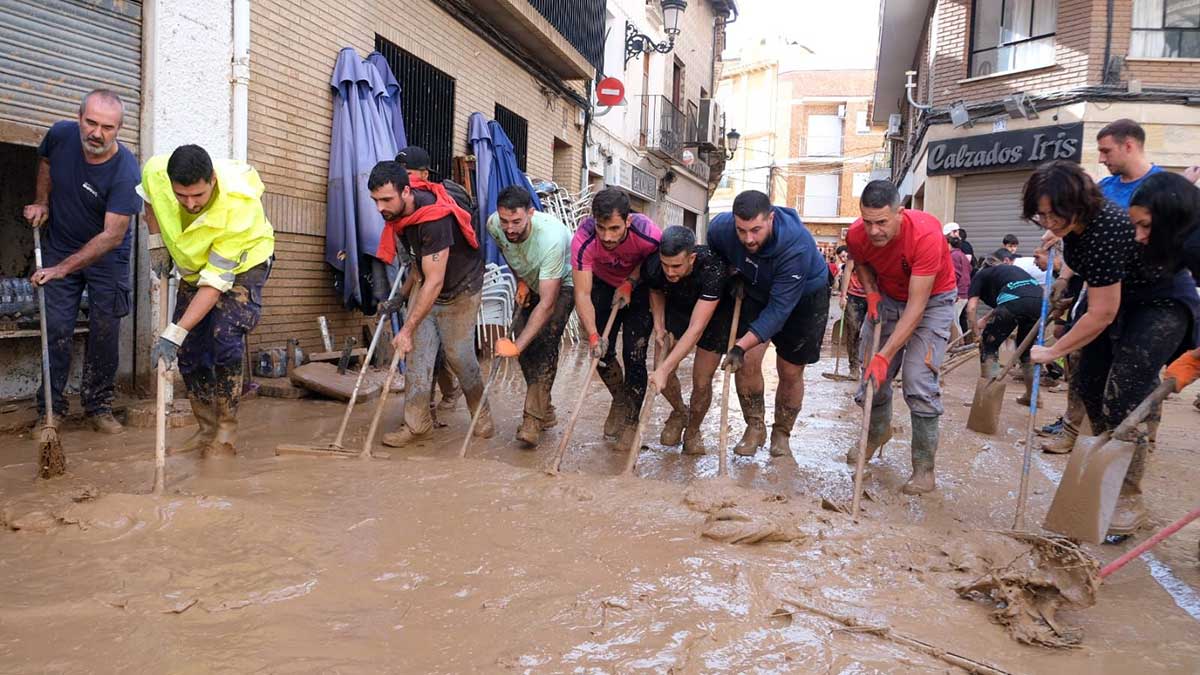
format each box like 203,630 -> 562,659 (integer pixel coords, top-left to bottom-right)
1042,377 -> 1175,544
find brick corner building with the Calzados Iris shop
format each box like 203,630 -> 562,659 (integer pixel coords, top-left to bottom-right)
874,0 -> 1200,255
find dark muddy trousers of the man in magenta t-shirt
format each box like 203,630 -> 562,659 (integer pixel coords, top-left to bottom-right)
592,277 -> 654,425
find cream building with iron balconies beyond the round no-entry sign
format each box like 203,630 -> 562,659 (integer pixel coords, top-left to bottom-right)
587,0 -> 737,237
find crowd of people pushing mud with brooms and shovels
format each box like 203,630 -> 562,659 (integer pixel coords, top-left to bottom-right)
25,90 -> 1200,533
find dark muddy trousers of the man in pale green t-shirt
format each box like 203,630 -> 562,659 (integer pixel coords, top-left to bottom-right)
512,285 -> 575,422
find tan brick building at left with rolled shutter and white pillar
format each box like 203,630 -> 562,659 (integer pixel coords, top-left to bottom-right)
0,0 -> 600,399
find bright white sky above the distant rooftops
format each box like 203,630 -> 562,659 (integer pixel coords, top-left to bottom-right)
725,0 -> 880,68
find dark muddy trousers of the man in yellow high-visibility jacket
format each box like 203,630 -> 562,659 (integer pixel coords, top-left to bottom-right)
172,261 -> 271,401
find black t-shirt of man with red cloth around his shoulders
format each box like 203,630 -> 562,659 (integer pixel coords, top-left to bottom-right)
403,190 -> 484,303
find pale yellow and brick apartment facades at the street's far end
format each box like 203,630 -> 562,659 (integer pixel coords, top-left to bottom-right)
713,41 -> 887,250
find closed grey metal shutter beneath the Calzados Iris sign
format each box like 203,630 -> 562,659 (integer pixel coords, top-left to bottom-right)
954,171 -> 1042,257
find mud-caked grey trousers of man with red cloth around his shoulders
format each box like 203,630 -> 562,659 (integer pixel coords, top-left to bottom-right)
404,286 -> 487,436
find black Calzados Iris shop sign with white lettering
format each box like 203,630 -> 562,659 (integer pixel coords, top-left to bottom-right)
926,123 -> 1084,175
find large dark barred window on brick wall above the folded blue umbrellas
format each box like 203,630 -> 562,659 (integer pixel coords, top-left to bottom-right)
376,35 -> 455,178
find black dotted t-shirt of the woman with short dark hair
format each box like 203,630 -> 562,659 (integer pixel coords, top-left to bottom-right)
1062,201 -> 1141,288
